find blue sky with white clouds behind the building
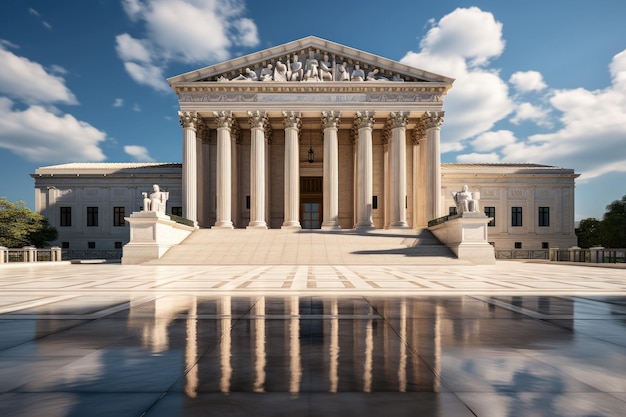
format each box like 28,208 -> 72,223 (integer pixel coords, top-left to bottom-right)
0,0 -> 626,220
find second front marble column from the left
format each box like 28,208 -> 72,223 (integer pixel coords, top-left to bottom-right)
213,111 -> 233,229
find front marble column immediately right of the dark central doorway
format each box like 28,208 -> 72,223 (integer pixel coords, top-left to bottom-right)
322,111 -> 341,230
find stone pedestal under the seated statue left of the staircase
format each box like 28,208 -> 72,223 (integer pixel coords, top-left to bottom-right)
122,211 -> 194,265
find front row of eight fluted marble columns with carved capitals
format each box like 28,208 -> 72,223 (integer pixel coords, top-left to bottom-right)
179,110 -> 443,229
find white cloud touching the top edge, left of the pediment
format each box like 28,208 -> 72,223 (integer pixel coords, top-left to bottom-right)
116,0 -> 259,90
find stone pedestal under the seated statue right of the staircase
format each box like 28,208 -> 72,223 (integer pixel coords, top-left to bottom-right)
429,213 -> 496,265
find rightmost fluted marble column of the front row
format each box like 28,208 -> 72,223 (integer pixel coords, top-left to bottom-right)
424,111 -> 444,220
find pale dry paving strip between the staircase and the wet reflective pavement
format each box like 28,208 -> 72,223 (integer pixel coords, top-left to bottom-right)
0,261 -> 626,296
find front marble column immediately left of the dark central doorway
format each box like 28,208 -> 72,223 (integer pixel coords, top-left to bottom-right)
282,111 -> 302,229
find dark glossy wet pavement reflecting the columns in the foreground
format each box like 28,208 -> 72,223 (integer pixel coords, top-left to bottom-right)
0,278 -> 626,417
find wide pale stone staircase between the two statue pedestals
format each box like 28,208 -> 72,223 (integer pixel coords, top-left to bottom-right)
149,229 -> 465,265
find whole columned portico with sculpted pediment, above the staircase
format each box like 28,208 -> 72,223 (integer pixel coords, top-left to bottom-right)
168,37 -> 453,230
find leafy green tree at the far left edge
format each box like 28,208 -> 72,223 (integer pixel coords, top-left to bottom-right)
0,197 -> 58,248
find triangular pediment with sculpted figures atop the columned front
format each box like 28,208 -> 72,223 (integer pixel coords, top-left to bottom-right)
168,36 -> 454,88
